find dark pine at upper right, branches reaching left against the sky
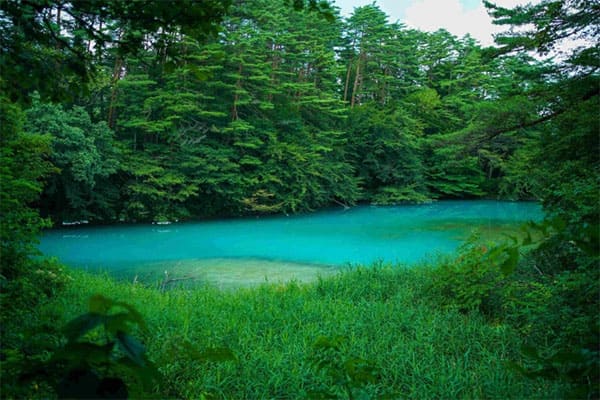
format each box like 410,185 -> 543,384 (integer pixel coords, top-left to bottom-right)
482,0 -> 600,223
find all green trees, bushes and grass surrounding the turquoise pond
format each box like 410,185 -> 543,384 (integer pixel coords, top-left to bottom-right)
0,0 -> 600,399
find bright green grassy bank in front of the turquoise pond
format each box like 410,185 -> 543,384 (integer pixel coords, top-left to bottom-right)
36,267 -> 562,399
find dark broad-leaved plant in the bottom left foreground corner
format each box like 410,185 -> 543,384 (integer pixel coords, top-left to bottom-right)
3,292 -> 160,398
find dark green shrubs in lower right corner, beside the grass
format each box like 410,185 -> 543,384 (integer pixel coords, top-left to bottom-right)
505,219 -> 600,398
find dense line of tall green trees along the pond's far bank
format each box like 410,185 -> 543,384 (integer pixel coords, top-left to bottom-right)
5,1 -> 592,222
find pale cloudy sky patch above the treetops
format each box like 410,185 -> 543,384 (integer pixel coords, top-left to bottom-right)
335,0 -> 539,46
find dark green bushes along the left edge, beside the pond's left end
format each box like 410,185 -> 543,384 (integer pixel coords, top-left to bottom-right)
0,96 -> 75,398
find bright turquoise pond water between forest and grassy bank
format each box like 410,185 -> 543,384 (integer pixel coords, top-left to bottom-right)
39,201 -> 543,281
